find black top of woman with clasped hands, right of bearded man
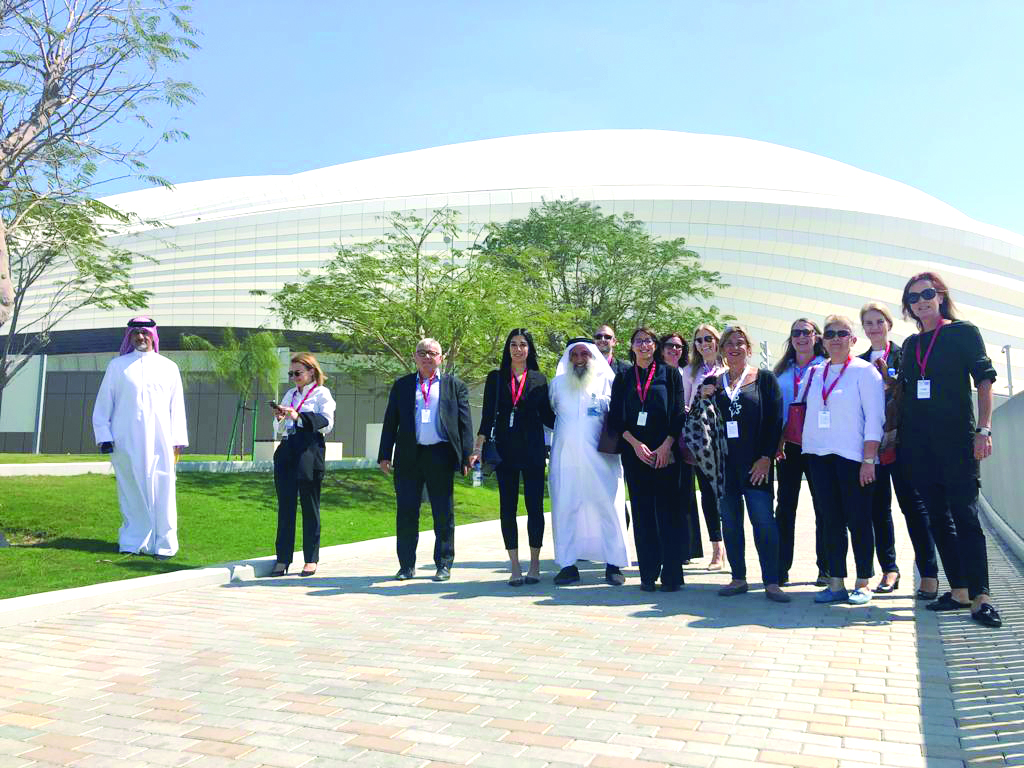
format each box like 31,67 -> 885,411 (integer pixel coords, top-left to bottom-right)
608,364 -> 686,451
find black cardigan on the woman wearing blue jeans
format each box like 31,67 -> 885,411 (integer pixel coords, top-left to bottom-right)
715,371 -> 782,494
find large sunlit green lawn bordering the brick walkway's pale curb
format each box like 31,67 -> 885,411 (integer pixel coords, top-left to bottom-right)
0,470 -> 540,598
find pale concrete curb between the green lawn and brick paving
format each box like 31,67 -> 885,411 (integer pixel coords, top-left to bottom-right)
0,519 -> 500,629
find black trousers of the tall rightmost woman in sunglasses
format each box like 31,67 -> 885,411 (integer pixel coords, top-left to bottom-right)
908,461 -> 989,600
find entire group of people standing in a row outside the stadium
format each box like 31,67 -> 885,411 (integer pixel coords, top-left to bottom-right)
93,271 -> 1001,627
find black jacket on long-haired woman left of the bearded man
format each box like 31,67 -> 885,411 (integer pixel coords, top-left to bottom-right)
477,371 -> 555,467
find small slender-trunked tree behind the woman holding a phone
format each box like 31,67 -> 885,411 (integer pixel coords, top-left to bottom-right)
181,328 -> 281,460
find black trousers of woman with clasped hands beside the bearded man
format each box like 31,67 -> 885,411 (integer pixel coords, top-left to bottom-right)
623,456 -> 690,587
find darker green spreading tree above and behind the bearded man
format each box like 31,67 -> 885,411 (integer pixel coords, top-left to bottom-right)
483,200 -> 724,348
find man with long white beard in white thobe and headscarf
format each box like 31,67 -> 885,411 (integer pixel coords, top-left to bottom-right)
549,339 -> 629,586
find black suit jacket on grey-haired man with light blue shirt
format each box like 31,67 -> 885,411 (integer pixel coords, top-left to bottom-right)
377,374 -> 473,471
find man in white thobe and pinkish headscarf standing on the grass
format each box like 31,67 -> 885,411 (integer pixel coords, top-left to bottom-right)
92,317 -> 188,559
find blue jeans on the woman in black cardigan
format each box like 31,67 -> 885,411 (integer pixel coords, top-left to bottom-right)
719,487 -> 778,584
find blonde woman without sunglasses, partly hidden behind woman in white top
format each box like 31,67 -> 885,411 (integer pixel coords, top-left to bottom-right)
860,301 -> 939,600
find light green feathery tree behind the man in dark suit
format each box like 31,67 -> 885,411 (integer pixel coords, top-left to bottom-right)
264,208 -> 561,383
